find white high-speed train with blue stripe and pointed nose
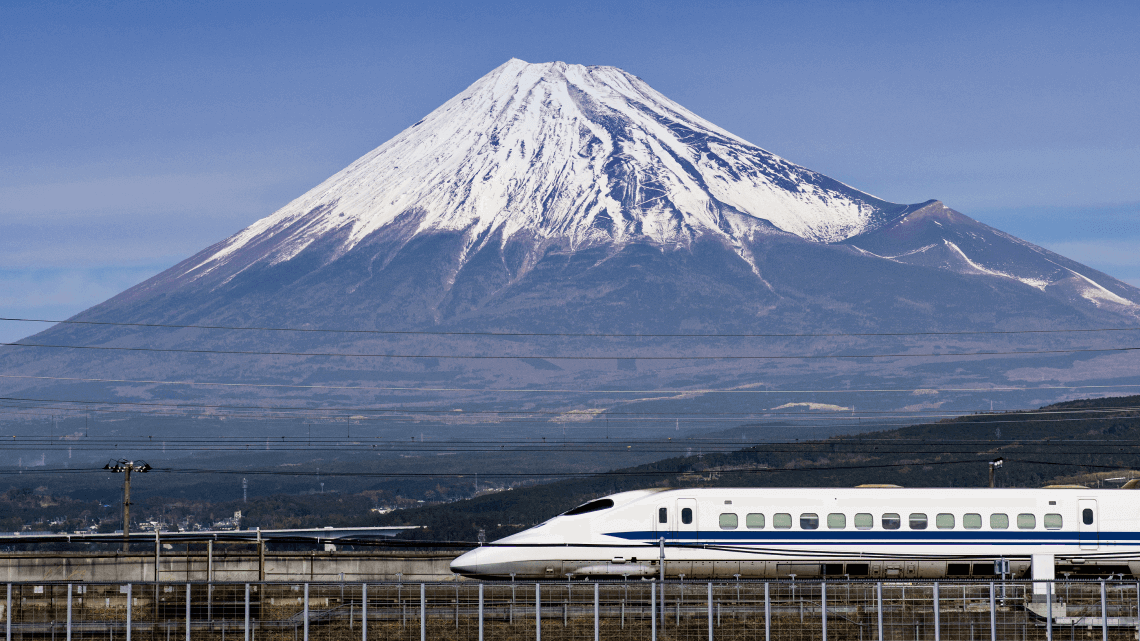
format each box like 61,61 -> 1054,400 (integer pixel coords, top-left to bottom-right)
451,484 -> 1140,579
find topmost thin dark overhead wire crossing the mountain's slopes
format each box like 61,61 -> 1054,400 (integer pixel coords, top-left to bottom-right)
0,317 -> 1140,339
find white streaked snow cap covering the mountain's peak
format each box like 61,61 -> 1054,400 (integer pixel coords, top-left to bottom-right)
192,58 -> 905,275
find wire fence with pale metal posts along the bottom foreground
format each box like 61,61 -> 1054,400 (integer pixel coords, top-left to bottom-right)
0,581 -> 1140,641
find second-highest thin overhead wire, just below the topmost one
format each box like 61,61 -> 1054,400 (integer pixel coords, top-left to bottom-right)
0,342 -> 1140,360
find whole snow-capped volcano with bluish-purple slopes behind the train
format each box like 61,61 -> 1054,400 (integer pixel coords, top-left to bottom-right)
0,59 -> 1140,424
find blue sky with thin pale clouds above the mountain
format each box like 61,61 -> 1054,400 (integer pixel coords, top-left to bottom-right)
0,0 -> 1140,340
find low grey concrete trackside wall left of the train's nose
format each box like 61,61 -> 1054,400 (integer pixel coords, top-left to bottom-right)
0,549 -> 458,583
